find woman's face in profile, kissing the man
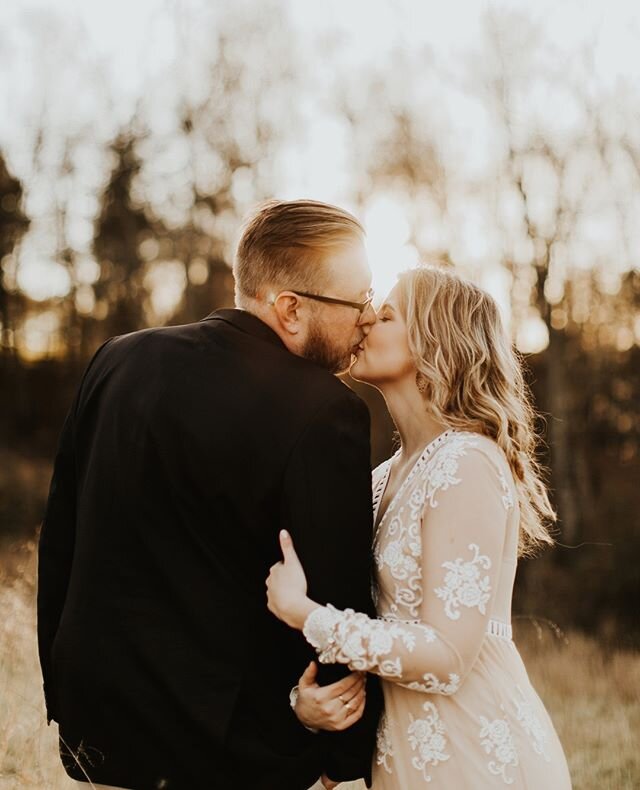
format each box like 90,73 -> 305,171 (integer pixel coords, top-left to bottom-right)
350,285 -> 416,387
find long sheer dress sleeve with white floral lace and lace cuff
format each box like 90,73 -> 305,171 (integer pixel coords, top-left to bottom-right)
304,446 -> 513,694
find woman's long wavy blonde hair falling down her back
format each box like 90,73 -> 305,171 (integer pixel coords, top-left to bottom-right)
399,266 -> 556,555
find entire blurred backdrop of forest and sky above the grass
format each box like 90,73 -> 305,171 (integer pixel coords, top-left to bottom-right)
0,0 -> 640,786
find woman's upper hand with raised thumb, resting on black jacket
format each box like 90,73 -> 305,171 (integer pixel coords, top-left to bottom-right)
267,529 -> 319,631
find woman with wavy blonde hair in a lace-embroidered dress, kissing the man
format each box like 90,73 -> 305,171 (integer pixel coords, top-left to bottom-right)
268,268 -> 571,790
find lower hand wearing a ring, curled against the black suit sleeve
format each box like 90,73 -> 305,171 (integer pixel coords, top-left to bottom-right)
295,661 -> 367,732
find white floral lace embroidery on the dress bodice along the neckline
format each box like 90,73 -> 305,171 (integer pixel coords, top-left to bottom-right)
373,433 -> 478,617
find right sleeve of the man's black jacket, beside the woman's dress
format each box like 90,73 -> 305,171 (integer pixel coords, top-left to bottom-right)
283,387 -> 381,781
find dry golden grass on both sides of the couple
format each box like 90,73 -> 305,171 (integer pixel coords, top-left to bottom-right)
0,546 -> 640,790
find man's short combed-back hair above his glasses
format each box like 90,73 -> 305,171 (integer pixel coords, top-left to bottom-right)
233,200 -> 364,301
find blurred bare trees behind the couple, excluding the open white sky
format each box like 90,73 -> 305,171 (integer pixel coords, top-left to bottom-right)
0,4 -> 640,643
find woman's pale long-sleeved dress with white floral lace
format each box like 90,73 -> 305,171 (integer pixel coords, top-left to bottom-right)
304,431 -> 571,790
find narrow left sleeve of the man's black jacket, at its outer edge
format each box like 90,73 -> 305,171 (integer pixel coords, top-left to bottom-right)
37,341 -> 114,723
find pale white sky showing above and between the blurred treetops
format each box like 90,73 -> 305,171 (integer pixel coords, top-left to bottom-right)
0,0 -> 640,356
